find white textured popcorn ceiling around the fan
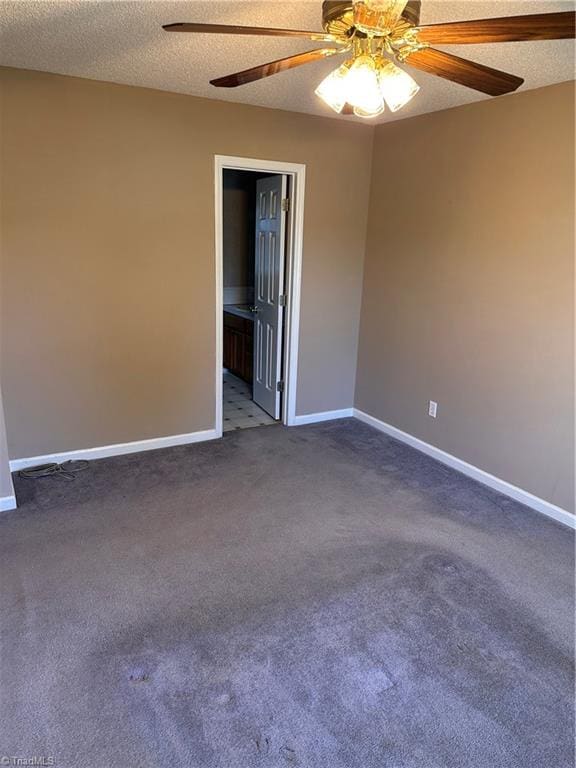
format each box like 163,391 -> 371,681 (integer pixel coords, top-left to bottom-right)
0,0 -> 575,122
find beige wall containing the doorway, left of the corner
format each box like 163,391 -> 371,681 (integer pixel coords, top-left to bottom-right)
1,69 -> 373,457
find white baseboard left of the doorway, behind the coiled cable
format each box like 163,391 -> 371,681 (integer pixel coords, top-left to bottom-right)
10,429 -> 221,472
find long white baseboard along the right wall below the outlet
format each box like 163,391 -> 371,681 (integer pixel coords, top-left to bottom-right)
354,408 -> 576,528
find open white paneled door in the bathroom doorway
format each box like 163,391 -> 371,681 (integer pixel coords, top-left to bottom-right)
252,175 -> 288,419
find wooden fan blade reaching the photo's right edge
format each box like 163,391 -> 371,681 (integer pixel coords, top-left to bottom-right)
418,11 -> 576,45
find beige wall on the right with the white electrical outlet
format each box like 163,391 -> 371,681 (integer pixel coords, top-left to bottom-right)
356,83 -> 574,510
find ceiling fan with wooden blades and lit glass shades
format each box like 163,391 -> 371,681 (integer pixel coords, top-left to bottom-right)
163,0 -> 576,118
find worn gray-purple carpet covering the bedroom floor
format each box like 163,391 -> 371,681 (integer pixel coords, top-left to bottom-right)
0,420 -> 574,768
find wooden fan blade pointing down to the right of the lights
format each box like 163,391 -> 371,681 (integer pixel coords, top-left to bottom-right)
406,48 -> 524,96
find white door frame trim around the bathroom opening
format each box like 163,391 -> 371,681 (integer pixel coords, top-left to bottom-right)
214,155 -> 306,437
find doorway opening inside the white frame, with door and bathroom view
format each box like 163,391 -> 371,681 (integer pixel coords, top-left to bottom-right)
222,168 -> 288,432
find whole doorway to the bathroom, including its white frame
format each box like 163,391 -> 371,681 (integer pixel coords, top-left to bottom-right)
215,156 -> 305,436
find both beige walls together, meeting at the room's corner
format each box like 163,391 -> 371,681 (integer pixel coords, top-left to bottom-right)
0,69 -> 574,509
